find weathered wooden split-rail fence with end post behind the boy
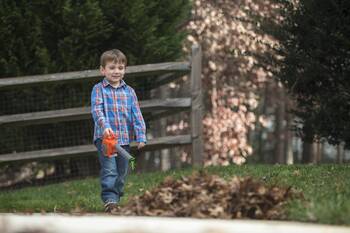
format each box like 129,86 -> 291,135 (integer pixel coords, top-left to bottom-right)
0,45 -> 203,165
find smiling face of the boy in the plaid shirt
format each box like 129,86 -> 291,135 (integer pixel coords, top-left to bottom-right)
100,61 -> 125,86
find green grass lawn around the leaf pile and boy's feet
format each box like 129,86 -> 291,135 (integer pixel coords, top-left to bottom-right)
0,165 -> 350,225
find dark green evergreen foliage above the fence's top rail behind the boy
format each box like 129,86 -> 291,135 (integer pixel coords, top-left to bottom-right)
0,0 -> 190,74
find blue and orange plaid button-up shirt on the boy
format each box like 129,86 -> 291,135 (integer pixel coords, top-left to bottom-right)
91,79 -> 146,145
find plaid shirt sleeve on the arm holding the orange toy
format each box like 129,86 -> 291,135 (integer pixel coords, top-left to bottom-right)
91,85 -> 111,132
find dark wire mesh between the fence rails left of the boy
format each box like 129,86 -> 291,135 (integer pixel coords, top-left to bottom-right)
0,80 -> 98,191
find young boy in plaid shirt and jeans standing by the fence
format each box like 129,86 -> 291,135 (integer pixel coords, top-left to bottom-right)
91,49 -> 146,213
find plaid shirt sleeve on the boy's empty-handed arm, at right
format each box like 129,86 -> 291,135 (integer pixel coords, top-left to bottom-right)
131,89 -> 147,143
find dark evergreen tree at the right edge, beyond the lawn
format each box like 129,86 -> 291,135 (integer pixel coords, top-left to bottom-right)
265,0 -> 350,147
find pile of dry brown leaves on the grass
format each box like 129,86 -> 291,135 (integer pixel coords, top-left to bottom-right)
119,172 -> 293,219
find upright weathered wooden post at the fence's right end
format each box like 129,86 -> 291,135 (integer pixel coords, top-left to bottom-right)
191,45 -> 203,166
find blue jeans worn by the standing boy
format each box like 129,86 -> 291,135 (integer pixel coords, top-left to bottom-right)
95,139 -> 130,203
